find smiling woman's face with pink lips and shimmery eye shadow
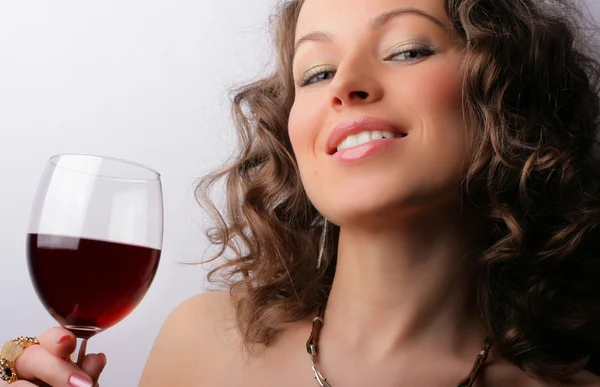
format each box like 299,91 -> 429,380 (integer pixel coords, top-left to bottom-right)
289,0 -> 468,226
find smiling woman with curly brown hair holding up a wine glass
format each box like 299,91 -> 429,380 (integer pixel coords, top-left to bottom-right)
3,0 -> 600,387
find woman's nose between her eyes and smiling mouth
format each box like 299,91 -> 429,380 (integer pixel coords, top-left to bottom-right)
330,55 -> 384,109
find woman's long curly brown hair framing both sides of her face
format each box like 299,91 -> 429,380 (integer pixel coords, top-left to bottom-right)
197,0 -> 600,380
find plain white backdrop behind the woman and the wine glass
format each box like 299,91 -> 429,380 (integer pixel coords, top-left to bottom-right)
0,0 -> 600,387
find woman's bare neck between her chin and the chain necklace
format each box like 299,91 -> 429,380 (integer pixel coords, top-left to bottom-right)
323,205 -> 484,356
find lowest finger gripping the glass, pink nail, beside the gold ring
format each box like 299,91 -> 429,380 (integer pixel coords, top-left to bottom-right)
11,345 -> 93,387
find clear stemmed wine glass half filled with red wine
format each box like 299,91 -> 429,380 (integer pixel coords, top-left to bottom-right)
27,155 -> 163,365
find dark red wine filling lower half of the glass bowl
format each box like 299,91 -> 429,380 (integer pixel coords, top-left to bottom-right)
27,234 -> 160,339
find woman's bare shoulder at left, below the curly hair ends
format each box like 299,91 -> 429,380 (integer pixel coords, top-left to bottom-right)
140,291 -> 240,387
